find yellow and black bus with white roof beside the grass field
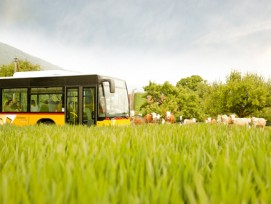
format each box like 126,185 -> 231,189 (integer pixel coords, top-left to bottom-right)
0,71 -> 130,126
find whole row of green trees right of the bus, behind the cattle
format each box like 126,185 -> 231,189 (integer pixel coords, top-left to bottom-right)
136,71 -> 271,121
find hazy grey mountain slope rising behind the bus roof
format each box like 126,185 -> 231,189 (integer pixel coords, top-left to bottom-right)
0,42 -> 63,70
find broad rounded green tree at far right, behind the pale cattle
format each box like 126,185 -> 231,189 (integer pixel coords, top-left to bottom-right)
208,71 -> 270,117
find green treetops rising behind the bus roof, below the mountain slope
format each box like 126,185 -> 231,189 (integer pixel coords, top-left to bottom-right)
0,60 -> 40,77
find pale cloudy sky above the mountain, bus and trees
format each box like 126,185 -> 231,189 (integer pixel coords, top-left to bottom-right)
0,0 -> 271,91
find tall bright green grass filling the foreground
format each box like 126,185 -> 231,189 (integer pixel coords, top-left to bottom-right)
0,124 -> 271,204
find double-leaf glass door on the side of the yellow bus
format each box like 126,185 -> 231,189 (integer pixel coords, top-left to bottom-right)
66,86 -> 96,126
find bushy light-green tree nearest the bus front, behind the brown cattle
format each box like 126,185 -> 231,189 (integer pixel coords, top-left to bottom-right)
141,80 -> 207,120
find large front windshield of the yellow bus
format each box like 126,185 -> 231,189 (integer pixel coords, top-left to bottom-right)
99,80 -> 129,118
